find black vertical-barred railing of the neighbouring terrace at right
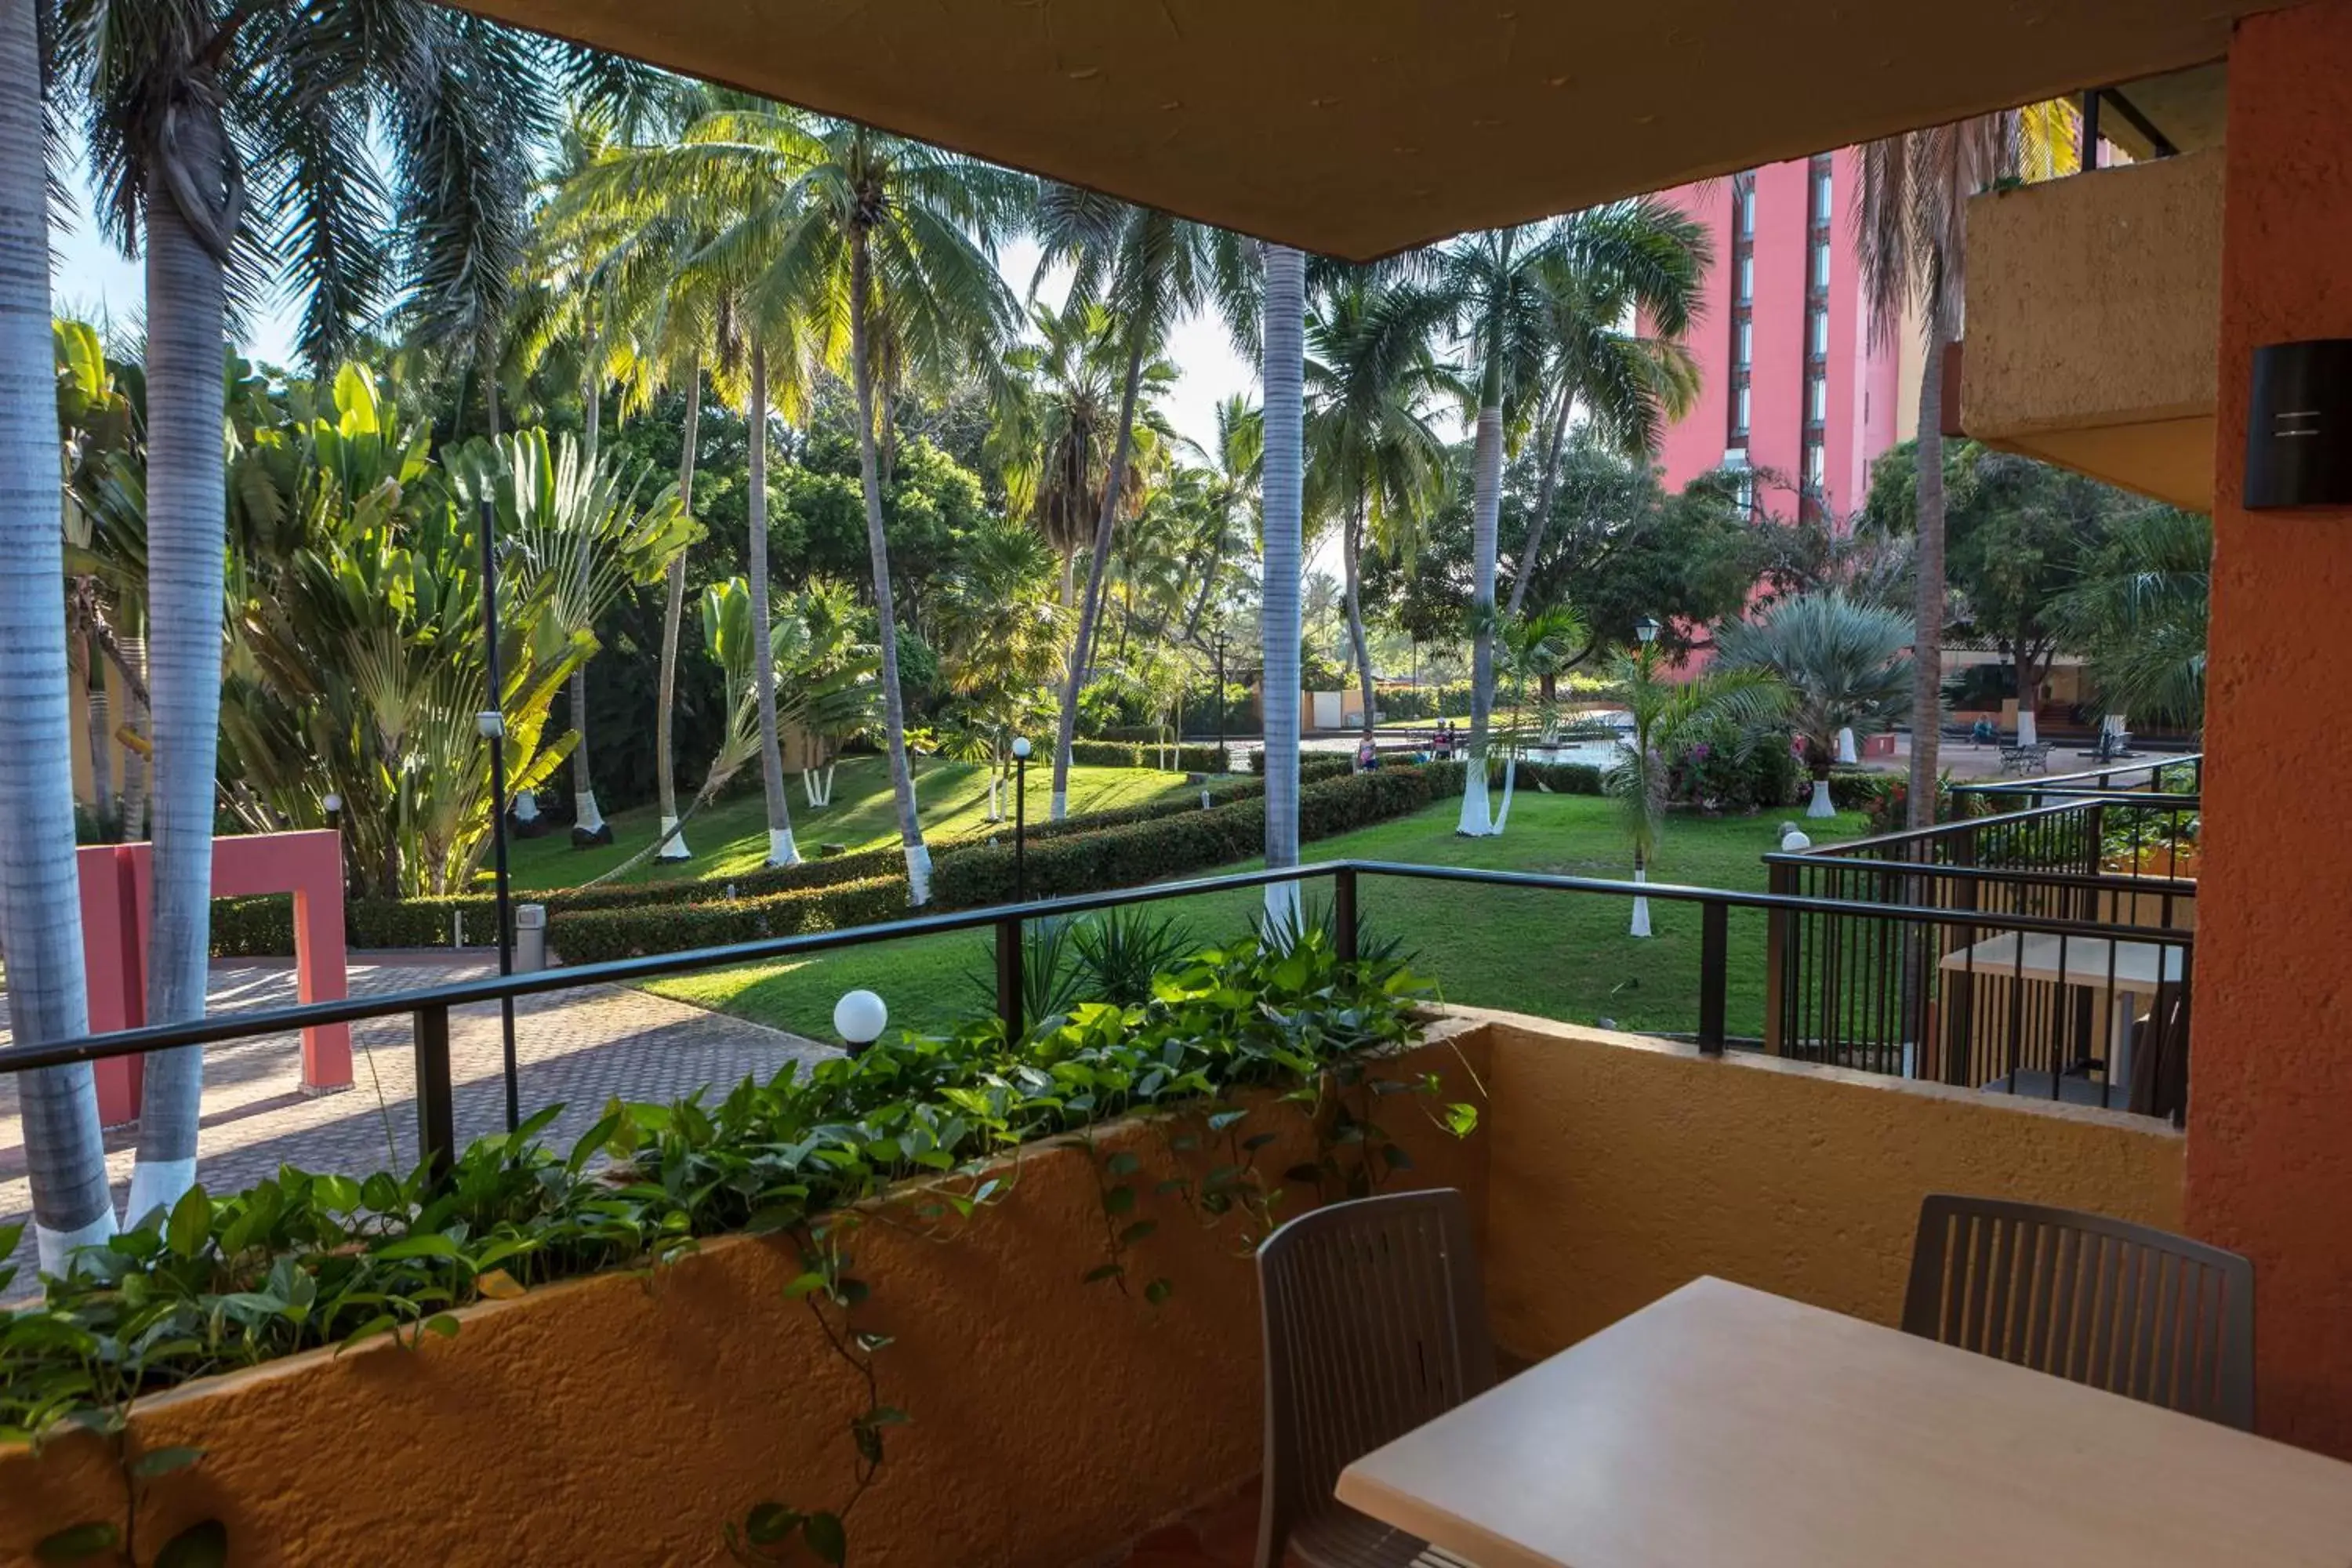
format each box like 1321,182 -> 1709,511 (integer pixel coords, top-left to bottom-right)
1764,780 -> 2199,1116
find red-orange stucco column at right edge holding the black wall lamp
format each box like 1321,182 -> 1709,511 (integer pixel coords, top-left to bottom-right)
2150,0 -> 2352,1457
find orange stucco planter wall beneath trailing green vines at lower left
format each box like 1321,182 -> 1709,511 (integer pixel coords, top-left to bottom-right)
0,1039 -> 1486,1568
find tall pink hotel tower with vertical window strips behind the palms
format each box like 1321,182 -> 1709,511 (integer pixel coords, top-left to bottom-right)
1661,148 -> 1919,520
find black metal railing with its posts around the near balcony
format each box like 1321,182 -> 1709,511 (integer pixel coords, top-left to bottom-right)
0,860 -> 2187,1194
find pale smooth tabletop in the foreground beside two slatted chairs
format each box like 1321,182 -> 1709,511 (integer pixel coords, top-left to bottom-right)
1338,1279 -> 2352,1568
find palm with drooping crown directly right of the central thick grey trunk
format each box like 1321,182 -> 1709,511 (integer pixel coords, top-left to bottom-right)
1305,273 -> 1451,736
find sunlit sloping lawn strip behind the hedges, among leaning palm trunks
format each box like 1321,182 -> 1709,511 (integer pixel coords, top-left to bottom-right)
513,757 -> 1185,891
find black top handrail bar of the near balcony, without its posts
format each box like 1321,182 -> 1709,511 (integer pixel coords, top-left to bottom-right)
0,860 -> 2194,1074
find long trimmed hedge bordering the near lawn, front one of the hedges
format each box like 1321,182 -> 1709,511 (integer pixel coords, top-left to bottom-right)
548,764 -> 1463,964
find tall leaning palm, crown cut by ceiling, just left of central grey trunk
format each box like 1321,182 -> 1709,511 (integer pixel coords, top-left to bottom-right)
1037,186 -> 1247,820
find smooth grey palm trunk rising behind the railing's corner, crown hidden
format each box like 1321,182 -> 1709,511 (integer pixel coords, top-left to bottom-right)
1261,245 -> 1308,931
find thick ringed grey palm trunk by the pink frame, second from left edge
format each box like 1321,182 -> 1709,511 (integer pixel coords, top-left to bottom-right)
127,115 -> 230,1222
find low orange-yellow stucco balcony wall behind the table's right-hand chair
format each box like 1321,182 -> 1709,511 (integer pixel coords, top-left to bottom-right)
1486,1013 -> 2183,1359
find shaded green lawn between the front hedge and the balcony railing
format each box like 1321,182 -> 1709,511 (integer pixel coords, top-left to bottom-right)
654,792 -> 1863,1039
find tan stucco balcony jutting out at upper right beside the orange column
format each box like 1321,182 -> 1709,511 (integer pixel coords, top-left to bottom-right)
1959,148 -> 2223,510
